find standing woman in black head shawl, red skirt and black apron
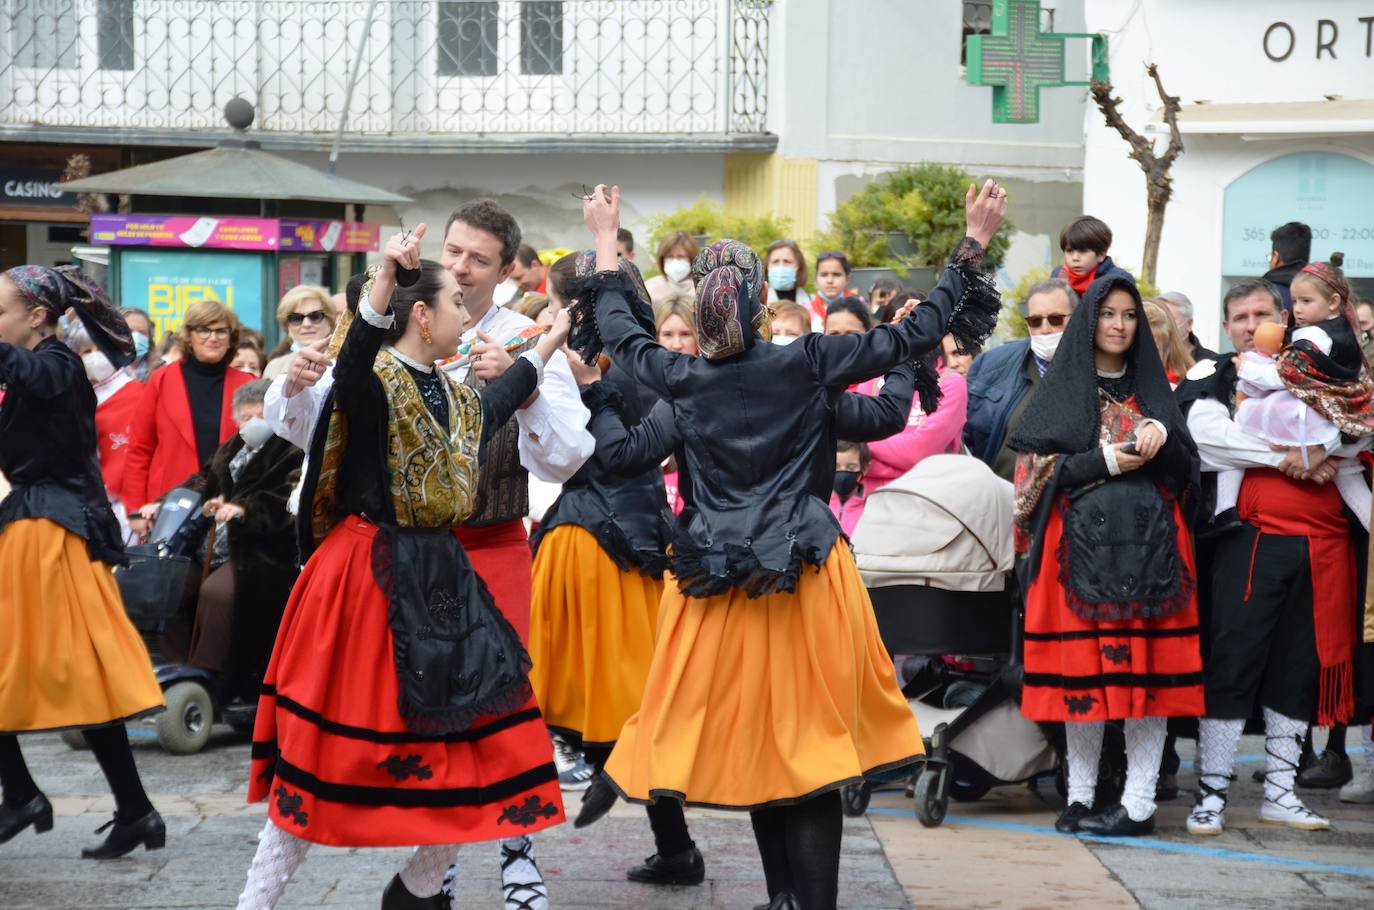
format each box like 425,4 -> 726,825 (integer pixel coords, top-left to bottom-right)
1010,276 -> 1202,834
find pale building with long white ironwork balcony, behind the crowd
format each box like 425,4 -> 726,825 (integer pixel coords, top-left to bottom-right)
0,0 -> 1087,292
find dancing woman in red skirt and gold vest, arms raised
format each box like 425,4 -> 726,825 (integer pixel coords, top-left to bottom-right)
238,225 -> 567,910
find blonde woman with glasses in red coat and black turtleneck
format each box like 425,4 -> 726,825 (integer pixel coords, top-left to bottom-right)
124,300 -> 254,535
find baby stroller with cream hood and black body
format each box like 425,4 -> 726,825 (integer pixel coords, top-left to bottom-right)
845,455 -> 1059,828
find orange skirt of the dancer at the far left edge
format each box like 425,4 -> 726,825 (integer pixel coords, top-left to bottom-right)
0,518 -> 162,733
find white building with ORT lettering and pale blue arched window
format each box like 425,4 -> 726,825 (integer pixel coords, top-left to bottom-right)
1084,0 -> 1374,346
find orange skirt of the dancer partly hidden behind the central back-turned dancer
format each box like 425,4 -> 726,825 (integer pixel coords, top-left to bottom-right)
529,525 -> 664,745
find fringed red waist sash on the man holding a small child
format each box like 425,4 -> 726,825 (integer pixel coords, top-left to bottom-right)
1238,467 -> 1358,727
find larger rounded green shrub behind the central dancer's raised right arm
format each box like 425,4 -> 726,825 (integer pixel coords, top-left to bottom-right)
820,164 -> 1014,269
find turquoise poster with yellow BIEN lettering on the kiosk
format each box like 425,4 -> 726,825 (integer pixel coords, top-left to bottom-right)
120,250 -> 262,338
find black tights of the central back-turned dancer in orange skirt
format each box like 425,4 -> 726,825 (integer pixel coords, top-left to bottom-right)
749,790 -> 844,910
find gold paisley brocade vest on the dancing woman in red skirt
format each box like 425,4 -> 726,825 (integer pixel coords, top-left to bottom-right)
312,349 -> 482,540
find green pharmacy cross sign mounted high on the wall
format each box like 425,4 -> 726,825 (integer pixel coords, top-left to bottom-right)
967,0 -> 1107,124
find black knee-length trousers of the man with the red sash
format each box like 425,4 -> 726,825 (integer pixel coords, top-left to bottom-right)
1204,524 -> 1322,722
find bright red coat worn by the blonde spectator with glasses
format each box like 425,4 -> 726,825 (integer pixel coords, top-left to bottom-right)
124,362 -> 256,511
